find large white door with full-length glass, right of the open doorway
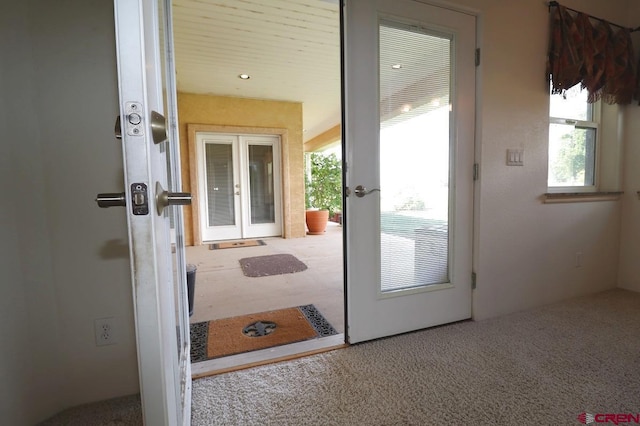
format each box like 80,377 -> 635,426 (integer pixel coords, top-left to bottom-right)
345,0 -> 476,343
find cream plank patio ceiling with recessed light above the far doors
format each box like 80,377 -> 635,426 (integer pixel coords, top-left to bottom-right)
173,0 -> 340,141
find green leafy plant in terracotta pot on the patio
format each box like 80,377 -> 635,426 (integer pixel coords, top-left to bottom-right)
305,152 -> 342,235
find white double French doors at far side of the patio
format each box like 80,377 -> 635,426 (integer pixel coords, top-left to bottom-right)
196,132 -> 282,241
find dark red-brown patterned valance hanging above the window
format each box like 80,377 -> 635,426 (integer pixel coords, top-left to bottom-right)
547,2 -> 640,105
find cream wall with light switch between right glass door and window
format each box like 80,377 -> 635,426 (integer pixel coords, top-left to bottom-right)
450,0 -> 627,319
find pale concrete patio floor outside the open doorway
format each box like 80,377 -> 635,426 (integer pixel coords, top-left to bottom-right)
186,222 -> 344,333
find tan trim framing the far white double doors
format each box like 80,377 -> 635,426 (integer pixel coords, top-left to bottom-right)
187,124 -> 293,246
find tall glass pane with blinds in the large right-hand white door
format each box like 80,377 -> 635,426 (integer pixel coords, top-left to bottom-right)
379,21 -> 452,292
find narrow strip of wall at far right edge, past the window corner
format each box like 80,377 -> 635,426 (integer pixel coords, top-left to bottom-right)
618,1 -> 640,291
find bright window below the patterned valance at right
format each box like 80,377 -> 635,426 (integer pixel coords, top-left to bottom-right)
547,84 -> 600,192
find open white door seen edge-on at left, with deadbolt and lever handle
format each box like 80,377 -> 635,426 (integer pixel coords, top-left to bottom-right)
114,0 -> 191,426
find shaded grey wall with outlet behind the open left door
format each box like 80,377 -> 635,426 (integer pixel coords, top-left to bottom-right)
0,0 -> 139,425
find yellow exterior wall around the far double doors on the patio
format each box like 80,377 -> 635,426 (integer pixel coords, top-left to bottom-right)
178,93 -> 305,245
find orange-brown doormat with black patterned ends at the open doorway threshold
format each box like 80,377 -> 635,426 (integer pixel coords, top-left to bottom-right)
190,305 -> 338,362
